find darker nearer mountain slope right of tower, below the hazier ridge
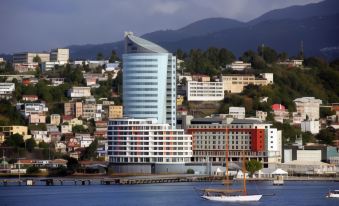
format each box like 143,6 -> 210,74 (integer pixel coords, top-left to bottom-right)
161,14 -> 339,56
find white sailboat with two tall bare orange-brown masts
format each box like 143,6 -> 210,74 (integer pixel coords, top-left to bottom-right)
201,138 -> 262,202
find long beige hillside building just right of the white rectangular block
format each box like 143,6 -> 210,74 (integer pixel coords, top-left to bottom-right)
222,73 -> 273,93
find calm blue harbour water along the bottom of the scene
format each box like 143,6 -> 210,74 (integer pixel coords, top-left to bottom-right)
0,181 -> 339,206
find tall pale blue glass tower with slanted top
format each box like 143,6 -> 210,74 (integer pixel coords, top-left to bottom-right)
122,32 -> 176,128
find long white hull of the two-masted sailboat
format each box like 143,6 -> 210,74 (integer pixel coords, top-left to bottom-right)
201,195 -> 262,202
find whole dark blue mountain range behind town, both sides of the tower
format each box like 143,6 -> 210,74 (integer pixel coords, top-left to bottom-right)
70,0 -> 339,59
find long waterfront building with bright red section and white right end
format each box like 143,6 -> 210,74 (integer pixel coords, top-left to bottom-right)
187,119 -> 282,166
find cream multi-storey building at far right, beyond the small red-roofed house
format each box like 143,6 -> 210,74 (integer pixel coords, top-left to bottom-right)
293,97 -> 322,120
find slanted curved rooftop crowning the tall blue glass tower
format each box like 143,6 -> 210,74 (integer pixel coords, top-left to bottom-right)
125,33 -> 169,53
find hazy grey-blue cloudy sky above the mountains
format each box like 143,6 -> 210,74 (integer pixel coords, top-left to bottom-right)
0,0 -> 321,53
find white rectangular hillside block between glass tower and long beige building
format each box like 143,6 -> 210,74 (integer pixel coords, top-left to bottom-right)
186,81 -> 224,101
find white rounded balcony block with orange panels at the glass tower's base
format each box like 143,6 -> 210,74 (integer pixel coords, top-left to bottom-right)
107,119 -> 192,164
